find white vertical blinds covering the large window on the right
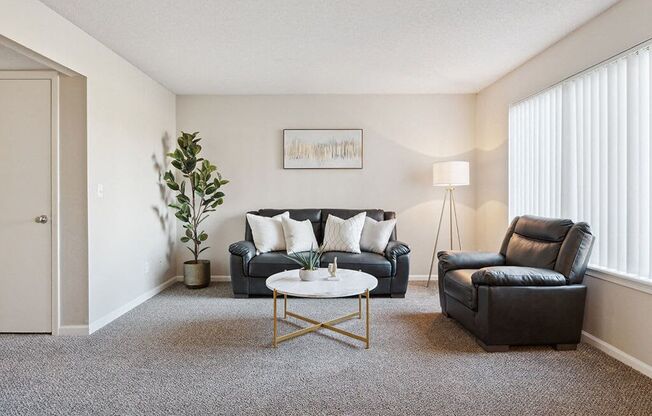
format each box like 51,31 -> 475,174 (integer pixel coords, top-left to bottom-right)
509,46 -> 652,279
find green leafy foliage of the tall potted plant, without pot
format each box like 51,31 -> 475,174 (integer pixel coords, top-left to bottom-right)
163,132 -> 229,262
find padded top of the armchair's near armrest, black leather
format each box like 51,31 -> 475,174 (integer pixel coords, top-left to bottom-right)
471,266 -> 567,286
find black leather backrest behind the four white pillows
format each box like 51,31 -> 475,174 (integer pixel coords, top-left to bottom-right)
245,208 -> 396,244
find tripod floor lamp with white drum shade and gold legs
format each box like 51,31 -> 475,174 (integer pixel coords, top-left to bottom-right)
426,161 -> 469,287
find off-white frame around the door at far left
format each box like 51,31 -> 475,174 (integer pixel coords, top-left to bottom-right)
0,70 -> 61,335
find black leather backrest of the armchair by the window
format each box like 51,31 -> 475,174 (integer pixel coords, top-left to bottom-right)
500,215 -> 594,284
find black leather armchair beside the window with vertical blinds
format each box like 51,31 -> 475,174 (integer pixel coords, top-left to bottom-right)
438,216 -> 594,351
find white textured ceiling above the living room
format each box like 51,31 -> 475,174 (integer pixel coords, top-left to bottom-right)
42,0 -> 617,94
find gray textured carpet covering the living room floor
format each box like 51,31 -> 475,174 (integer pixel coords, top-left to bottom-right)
0,283 -> 652,415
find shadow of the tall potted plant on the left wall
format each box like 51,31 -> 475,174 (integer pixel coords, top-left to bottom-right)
152,133 -> 176,268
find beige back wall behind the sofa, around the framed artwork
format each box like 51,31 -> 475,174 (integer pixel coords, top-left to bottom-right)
177,95 -> 475,275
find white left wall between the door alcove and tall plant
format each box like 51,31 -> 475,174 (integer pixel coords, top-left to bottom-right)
0,0 -> 175,325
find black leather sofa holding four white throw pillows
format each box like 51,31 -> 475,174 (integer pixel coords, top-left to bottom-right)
229,209 -> 410,298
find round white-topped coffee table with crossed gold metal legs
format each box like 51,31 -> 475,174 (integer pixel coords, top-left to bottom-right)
265,269 -> 378,348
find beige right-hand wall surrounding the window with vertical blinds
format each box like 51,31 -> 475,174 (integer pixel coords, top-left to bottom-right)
475,0 -> 652,364
